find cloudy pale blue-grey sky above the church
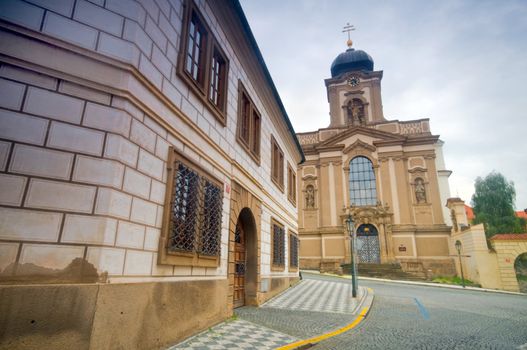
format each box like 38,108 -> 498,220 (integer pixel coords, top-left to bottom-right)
240,0 -> 527,210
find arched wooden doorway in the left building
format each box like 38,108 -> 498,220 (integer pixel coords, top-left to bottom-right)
233,208 -> 258,308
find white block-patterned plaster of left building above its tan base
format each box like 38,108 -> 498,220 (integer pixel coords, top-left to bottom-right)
0,0 -> 298,282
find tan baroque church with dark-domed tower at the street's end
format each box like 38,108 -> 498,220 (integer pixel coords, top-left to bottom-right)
297,40 -> 455,275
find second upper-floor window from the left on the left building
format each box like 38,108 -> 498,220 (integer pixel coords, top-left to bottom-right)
237,82 -> 261,164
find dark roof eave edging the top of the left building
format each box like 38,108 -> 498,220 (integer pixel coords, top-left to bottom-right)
232,0 -> 306,163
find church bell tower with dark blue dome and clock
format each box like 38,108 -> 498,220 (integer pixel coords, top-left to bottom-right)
325,39 -> 386,128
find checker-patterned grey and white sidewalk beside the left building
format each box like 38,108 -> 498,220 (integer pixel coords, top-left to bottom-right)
169,275 -> 368,350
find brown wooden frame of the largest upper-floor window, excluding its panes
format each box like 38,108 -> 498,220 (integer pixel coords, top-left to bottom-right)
176,0 -> 229,126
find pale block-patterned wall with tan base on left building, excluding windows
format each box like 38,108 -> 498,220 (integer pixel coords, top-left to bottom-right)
0,0 -> 300,349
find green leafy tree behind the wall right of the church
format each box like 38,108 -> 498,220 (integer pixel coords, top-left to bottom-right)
472,171 -> 526,237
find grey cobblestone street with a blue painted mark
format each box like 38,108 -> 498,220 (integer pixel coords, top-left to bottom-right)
313,276 -> 527,350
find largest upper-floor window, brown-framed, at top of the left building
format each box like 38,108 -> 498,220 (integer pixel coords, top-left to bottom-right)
177,0 -> 229,125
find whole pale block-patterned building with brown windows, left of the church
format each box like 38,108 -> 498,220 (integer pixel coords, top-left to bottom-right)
0,0 -> 303,349
